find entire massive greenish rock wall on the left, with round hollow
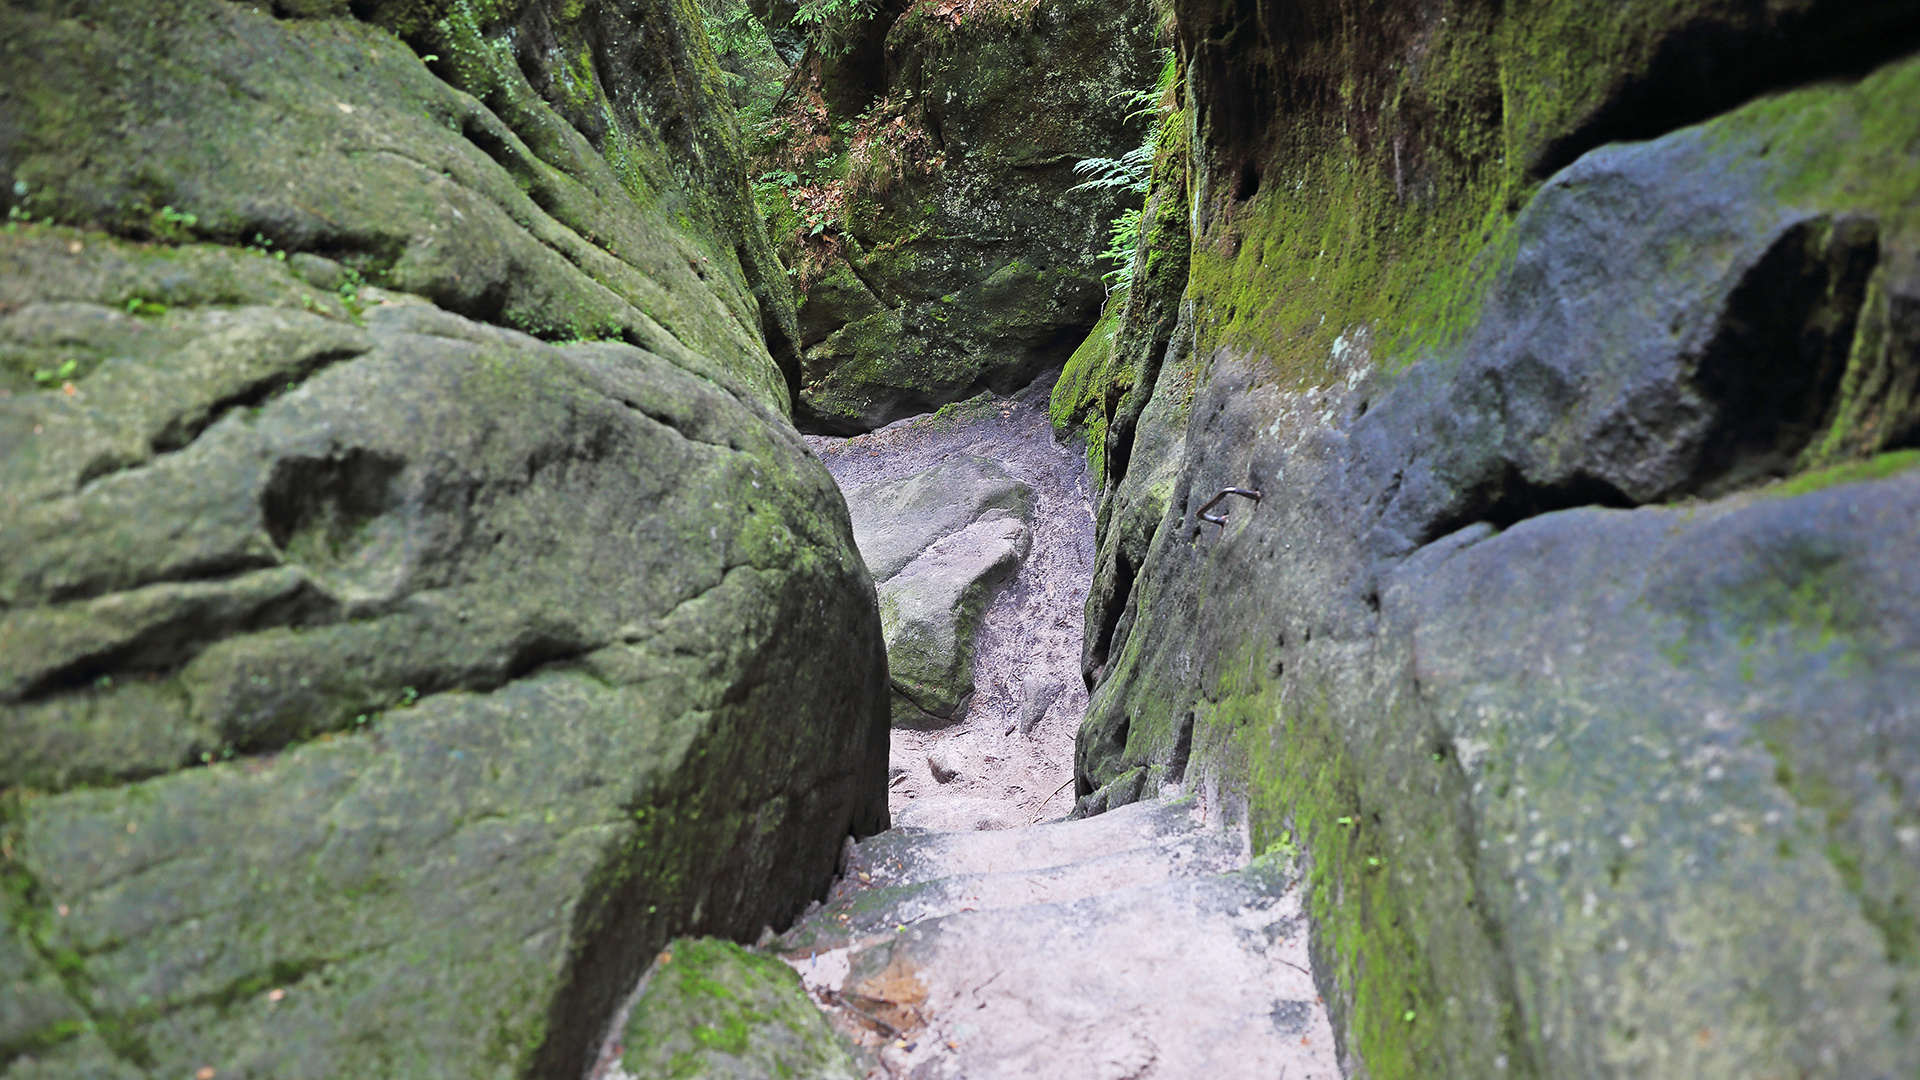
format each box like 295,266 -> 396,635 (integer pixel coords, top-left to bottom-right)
0,0 -> 887,1080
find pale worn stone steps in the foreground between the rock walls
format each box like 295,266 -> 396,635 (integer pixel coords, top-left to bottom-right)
780,799 -> 1340,1080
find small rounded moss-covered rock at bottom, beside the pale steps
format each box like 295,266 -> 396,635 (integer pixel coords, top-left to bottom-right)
618,938 -> 866,1080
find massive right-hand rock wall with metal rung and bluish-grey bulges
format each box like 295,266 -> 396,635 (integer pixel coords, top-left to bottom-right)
1090,14 -> 1920,1080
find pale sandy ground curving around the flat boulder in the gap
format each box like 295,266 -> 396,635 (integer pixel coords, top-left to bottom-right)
806,380 -> 1094,830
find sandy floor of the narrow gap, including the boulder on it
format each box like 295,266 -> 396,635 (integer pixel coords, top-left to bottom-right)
808,367 -> 1094,830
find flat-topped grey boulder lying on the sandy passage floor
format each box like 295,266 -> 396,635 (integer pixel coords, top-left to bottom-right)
847,455 -> 1033,724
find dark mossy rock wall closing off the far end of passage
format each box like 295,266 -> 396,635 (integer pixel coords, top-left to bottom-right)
774,0 -> 1160,434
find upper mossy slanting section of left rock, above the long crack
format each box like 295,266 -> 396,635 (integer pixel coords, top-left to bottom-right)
0,0 -> 797,407
